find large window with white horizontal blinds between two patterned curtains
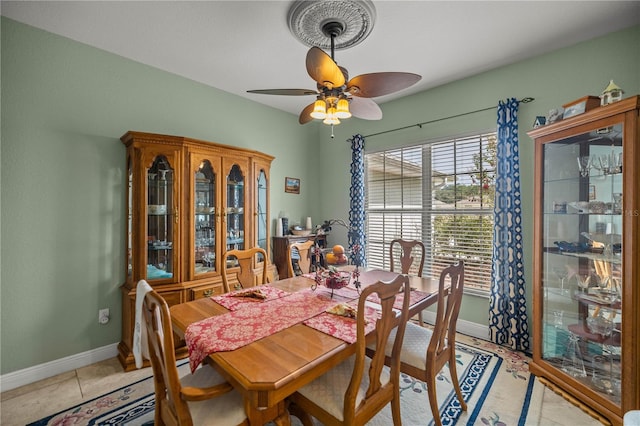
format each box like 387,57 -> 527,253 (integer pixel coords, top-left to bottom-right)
365,132 -> 496,293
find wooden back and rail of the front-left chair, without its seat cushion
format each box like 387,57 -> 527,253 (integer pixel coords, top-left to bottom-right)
142,291 -> 238,425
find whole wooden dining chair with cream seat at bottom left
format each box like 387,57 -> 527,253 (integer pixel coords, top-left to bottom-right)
142,290 -> 249,425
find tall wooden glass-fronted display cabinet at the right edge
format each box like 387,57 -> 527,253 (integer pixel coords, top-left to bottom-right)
529,96 -> 640,424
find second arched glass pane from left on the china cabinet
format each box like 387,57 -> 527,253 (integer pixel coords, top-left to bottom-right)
193,160 -> 219,276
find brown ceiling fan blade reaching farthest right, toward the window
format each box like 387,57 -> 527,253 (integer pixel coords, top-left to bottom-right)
347,72 -> 422,98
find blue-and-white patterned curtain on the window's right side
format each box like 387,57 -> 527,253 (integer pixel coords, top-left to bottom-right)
489,98 -> 529,352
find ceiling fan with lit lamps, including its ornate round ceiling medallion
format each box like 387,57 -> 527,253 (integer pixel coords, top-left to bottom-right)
248,0 -> 421,130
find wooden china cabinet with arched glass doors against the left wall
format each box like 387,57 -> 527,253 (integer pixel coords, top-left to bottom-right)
118,132 -> 275,371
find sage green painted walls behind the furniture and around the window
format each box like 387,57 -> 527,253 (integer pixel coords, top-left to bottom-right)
0,18 -> 640,374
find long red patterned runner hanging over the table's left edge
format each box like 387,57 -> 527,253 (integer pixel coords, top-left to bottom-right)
185,290 -> 338,372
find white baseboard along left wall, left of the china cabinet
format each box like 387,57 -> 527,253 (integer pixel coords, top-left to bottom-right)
0,343 -> 118,392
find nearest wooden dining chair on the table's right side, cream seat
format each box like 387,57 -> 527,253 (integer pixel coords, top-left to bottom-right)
288,275 -> 411,426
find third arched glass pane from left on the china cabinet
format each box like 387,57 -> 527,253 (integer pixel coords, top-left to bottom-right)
225,164 -> 245,251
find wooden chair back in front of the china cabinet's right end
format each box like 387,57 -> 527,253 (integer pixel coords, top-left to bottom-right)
222,247 -> 269,293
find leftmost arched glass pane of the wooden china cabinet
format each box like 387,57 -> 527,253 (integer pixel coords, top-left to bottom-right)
146,155 -> 177,280
